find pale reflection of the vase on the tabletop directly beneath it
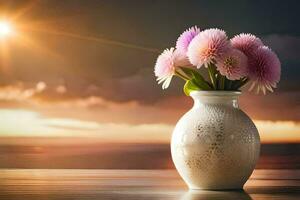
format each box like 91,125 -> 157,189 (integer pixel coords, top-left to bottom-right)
181,190 -> 252,200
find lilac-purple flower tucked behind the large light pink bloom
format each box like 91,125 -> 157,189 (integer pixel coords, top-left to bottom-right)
176,26 -> 200,55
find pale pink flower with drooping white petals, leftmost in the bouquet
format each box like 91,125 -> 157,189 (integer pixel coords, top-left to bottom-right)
154,48 -> 190,89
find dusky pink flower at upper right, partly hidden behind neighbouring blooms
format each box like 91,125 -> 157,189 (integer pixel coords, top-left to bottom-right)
230,33 -> 263,57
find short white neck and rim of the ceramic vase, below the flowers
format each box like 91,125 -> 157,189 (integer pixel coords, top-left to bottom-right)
191,91 -> 241,108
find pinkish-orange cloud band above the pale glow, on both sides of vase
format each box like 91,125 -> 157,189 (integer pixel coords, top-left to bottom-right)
0,78 -> 300,124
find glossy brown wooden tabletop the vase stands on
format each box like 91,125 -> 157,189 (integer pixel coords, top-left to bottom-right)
0,169 -> 300,200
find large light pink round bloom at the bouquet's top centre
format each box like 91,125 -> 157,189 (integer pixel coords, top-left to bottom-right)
187,29 -> 230,68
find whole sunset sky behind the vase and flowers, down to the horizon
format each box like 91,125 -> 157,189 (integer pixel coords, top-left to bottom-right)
0,0 -> 300,143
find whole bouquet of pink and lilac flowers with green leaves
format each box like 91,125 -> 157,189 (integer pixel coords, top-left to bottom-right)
154,26 -> 281,95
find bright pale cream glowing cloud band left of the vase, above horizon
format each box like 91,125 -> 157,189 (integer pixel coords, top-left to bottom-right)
0,109 -> 172,143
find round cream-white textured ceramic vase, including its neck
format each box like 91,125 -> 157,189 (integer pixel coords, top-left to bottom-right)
171,91 -> 260,190
